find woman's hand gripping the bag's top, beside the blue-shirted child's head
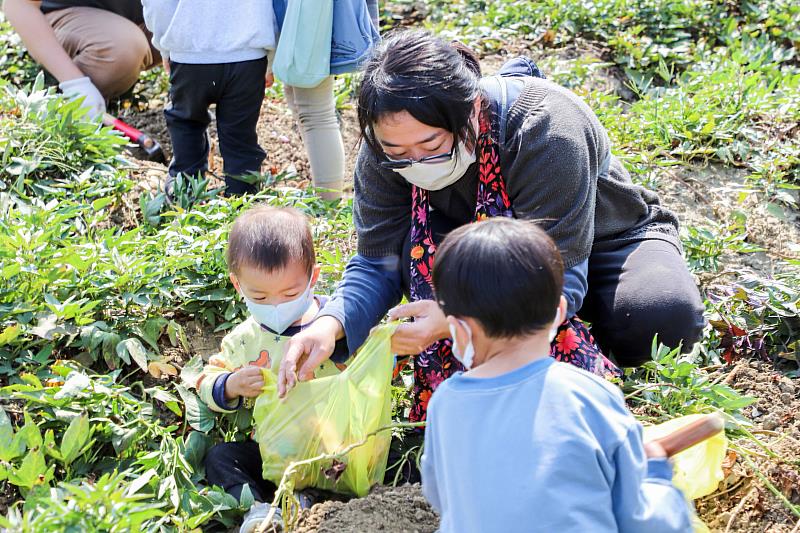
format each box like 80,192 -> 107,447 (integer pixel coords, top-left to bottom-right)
389,300 -> 450,355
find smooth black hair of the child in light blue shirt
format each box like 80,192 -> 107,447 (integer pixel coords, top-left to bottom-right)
433,217 -> 564,337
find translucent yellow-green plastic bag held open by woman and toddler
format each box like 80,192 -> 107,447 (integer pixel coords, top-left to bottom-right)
253,323 -> 398,496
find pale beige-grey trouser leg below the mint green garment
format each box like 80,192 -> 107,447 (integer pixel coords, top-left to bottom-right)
284,76 -> 344,200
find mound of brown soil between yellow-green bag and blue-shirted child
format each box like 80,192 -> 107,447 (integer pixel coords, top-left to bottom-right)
295,485 -> 439,533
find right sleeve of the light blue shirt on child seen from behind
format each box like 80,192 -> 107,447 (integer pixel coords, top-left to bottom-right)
612,424 -> 692,533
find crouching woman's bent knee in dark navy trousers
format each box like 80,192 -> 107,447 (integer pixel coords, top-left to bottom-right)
578,239 -> 705,366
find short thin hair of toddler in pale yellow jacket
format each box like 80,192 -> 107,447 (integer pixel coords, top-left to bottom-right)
227,206 -> 316,275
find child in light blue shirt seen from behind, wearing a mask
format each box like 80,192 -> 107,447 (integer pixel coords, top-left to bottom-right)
422,217 -> 691,533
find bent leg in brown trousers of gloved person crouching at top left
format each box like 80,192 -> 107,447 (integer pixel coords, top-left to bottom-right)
45,7 -> 161,99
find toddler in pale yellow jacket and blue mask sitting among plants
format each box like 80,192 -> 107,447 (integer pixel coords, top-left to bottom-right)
194,206 -> 349,532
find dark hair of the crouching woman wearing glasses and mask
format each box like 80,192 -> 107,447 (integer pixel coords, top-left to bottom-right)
358,30 -> 481,158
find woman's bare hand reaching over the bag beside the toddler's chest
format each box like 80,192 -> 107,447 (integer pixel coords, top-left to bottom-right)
278,316 -> 344,398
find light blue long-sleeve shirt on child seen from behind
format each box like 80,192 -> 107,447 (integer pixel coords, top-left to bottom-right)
422,357 -> 691,533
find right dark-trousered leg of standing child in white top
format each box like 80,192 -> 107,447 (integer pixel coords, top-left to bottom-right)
217,57 -> 267,196
